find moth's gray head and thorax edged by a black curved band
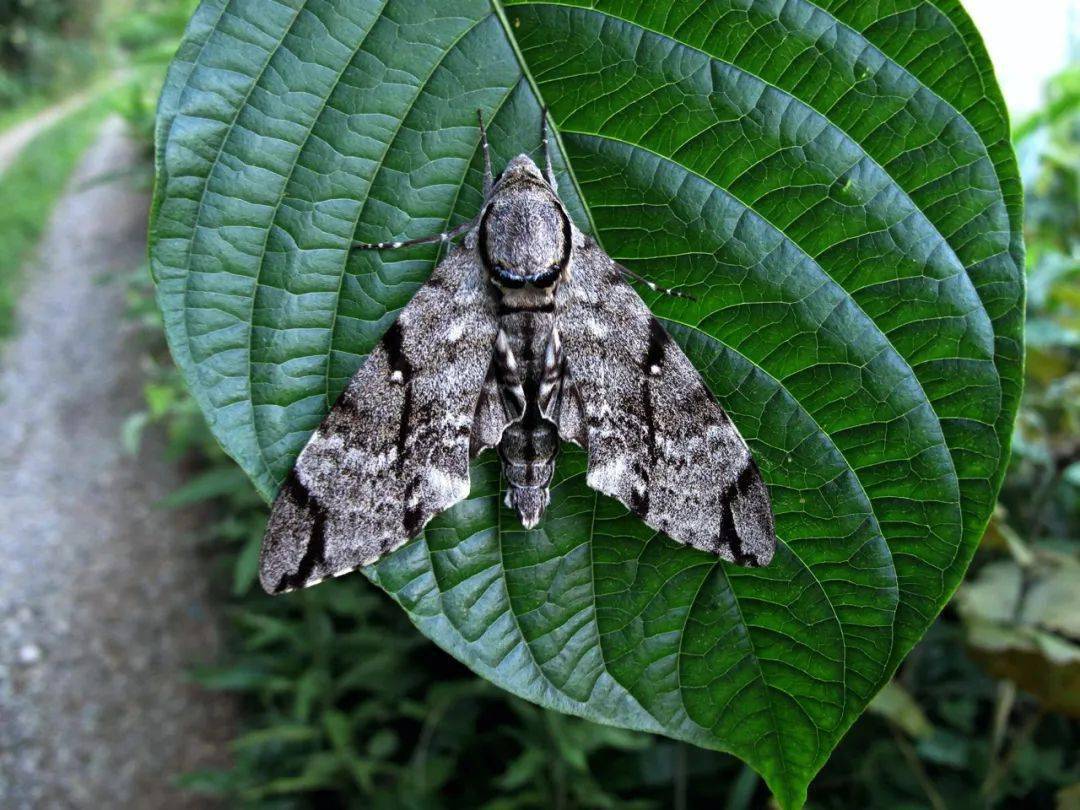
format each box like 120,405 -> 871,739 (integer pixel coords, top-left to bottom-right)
480,154 -> 571,289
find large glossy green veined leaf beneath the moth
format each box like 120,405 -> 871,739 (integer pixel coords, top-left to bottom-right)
152,0 -> 1023,807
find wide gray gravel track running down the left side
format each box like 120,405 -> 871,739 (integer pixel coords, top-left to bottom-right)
0,121 -> 232,809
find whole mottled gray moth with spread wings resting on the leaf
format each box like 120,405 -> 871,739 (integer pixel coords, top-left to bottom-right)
260,112 -> 775,593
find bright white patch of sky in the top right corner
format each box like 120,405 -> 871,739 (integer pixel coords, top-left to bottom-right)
963,0 -> 1080,121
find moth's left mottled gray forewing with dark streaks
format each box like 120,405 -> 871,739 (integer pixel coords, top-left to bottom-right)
259,246 -> 497,593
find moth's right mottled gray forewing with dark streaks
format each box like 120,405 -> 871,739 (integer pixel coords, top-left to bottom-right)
555,241 -> 777,566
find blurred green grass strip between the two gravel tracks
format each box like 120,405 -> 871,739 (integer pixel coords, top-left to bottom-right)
0,98 -> 110,340
